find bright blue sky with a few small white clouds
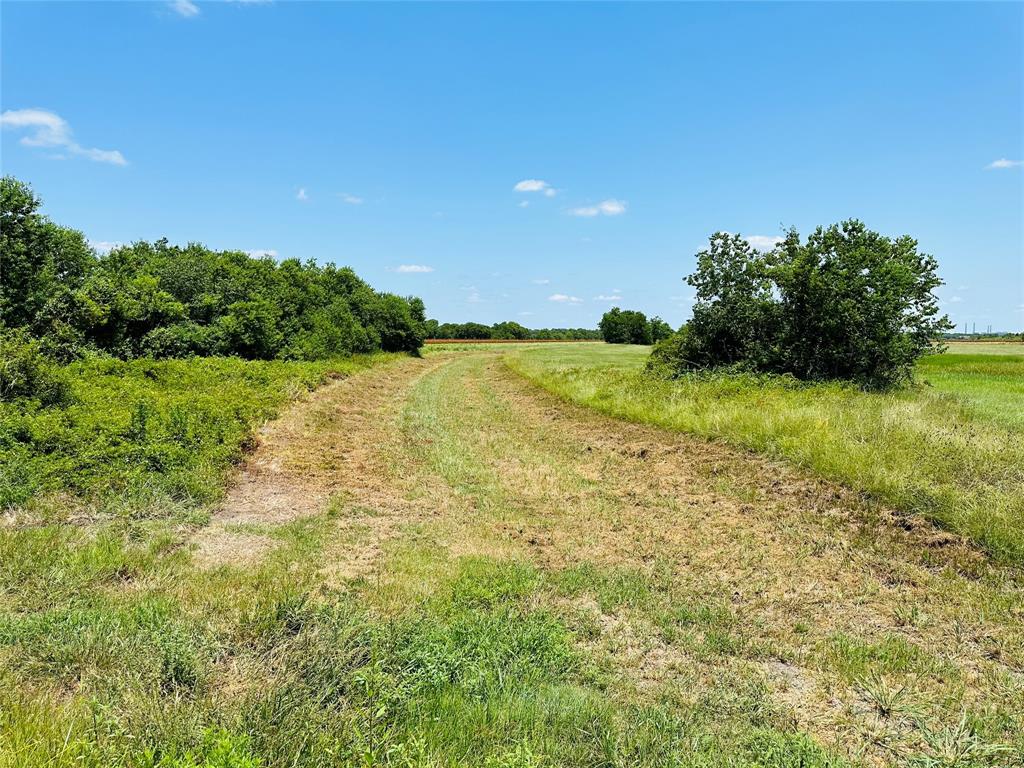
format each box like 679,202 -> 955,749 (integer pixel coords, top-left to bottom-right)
0,0 -> 1024,330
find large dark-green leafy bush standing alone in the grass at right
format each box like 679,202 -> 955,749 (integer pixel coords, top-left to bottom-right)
653,220 -> 952,389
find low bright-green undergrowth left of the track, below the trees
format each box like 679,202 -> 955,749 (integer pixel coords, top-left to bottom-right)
0,355 -> 395,518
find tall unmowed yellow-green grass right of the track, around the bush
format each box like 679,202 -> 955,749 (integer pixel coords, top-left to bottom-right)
508,344 -> 1024,564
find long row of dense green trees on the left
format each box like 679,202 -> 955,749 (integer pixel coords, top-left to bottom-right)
0,177 -> 426,360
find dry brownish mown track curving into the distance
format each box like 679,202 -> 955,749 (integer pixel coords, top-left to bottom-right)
197,351 -> 1024,764
